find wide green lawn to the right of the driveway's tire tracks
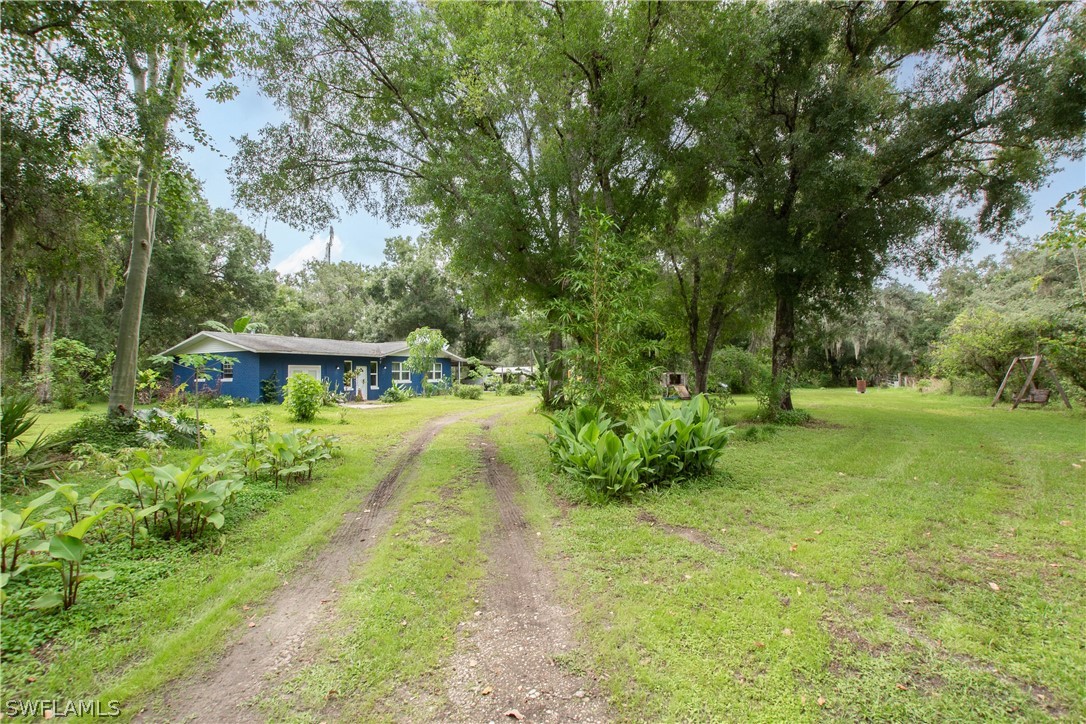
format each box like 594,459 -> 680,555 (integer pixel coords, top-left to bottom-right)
495,390 -> 1086,721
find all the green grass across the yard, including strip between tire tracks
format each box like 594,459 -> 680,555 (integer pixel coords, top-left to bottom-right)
3,390 -> 1086,721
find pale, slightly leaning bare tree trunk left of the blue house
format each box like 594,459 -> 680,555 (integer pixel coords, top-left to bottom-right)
109,164 -> 159,415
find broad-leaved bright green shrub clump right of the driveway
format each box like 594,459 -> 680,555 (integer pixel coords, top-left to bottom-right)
547,395 -> 732,499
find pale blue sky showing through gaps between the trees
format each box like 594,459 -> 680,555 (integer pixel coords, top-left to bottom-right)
185,74 -> 1086,288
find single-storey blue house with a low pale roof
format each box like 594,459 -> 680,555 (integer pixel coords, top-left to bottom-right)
162,332 -> 467,402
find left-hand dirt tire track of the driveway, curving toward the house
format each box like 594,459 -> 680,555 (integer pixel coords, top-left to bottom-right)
147,410 -> 471,724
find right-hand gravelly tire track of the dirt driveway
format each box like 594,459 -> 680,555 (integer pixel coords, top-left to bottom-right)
438,416 -> 609,722
